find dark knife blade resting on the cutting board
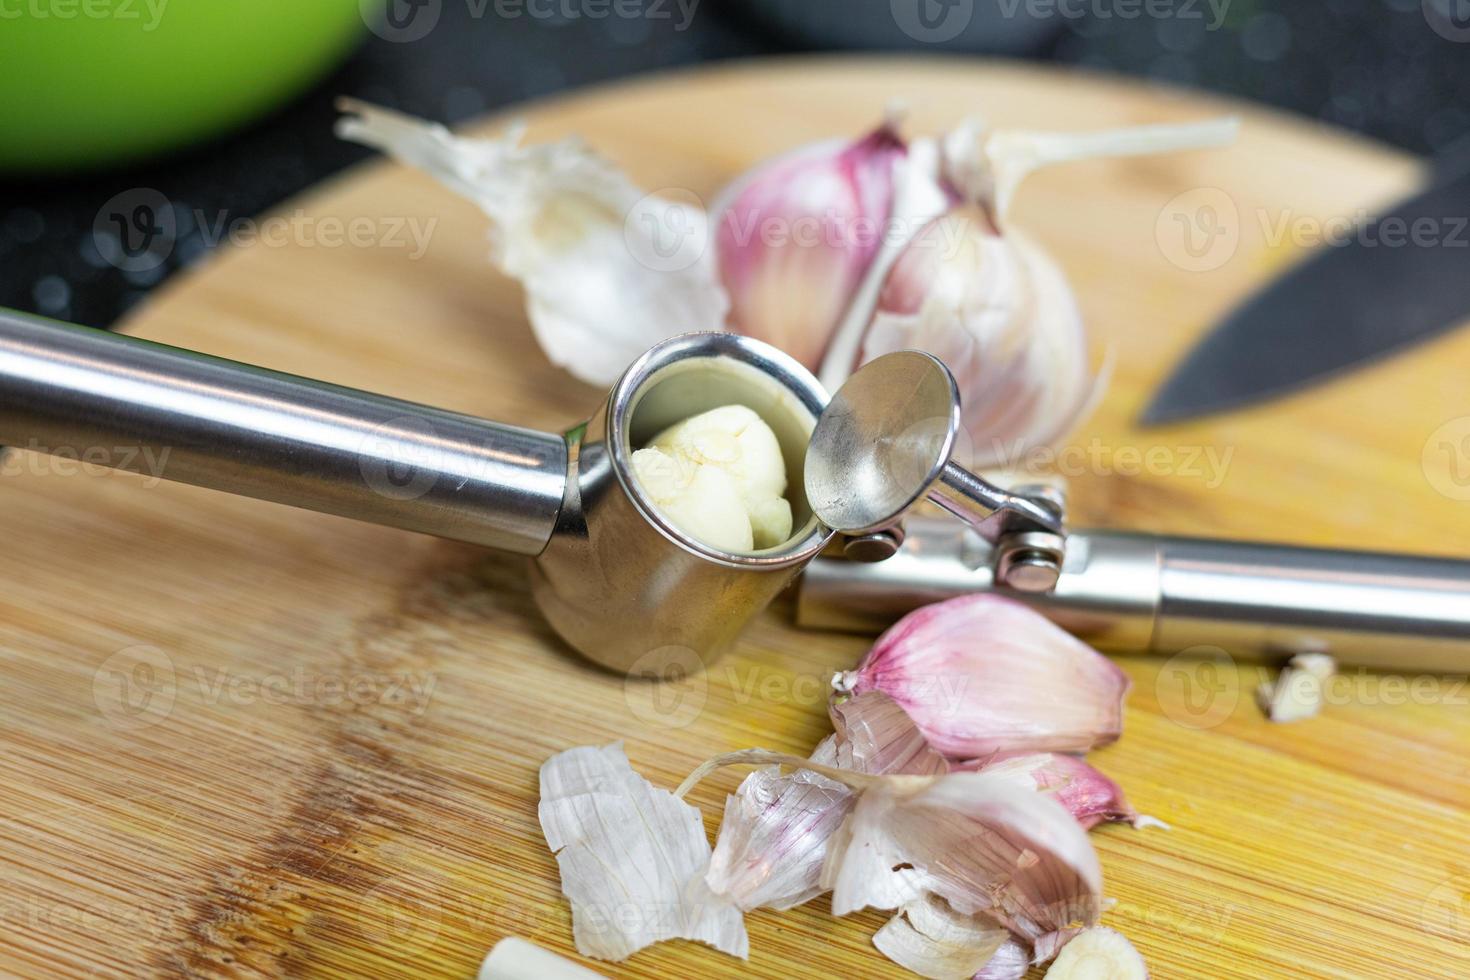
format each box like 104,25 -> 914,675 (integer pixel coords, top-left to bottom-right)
1139,154 -> 1470,425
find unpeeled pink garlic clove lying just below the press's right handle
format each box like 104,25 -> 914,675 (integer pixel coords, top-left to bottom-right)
833,594 -> 1129,760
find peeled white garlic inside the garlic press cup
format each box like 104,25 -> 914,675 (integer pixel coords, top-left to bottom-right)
632,406 -> 792,552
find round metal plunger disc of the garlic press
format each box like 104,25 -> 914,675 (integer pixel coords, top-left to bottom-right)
806,351 -> 960,535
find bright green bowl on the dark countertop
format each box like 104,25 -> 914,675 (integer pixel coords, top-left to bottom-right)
0,0 -> 373,172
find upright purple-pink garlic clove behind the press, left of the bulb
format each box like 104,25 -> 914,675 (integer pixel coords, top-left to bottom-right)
711,122 -> 907,370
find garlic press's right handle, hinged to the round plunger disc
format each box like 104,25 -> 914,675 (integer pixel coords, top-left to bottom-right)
797,517 -> 1470,673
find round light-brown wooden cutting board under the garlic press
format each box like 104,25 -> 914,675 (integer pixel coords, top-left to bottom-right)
0,59 -> 1470,979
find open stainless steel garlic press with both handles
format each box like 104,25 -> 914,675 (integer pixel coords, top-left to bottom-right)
0,311 -> 1470,673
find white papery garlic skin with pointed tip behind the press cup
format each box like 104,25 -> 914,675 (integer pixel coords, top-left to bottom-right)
337,100 -> 729,385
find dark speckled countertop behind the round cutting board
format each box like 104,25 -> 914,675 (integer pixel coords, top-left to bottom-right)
0,0 -> 1470,326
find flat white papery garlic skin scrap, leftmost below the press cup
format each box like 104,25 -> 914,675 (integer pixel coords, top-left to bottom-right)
537,743 -> 750,961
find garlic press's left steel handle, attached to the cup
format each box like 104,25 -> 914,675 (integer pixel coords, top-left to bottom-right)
0,310 -> 567,554
